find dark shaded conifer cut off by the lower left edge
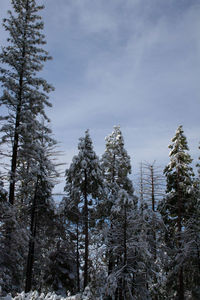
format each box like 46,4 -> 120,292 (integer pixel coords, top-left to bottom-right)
0,173 -> 27,295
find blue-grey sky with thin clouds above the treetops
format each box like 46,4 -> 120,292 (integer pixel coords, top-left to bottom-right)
0,0 -> 200,193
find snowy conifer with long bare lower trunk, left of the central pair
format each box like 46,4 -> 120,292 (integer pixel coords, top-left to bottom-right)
64,130 -> 103,288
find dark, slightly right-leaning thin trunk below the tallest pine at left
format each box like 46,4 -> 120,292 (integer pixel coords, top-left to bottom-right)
25,180 -> 38,293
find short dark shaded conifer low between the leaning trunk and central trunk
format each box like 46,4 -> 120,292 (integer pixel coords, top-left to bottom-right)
40,213 -> 76,296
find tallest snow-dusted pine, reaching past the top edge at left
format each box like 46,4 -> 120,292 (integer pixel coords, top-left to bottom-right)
0,0 -> 53,204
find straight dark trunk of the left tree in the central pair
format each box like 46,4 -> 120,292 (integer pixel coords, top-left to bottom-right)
84,170 -> 89,288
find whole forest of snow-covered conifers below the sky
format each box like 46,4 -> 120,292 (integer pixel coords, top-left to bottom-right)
0,0 -> 200,300
